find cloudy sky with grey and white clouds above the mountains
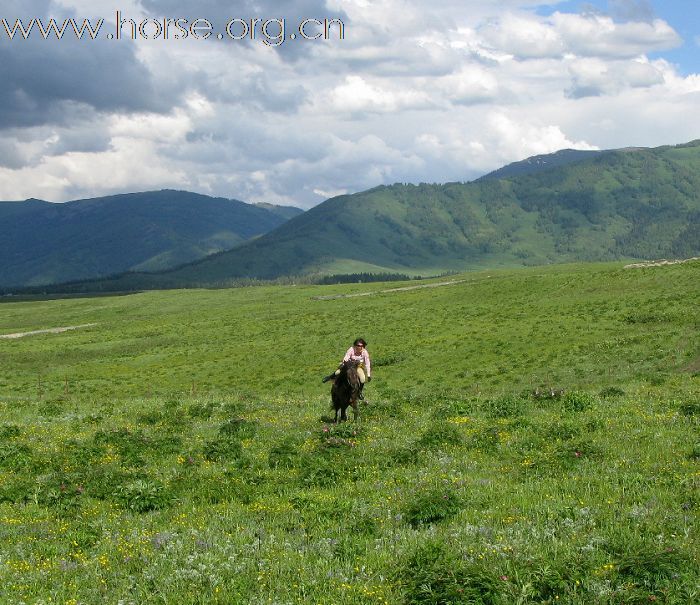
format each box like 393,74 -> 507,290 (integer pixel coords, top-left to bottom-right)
0,0 -> 700,208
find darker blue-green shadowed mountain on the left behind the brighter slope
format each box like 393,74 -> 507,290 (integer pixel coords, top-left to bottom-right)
0,190 -> 301,286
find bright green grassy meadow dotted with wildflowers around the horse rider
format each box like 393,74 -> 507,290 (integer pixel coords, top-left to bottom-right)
0,262 -> 700,605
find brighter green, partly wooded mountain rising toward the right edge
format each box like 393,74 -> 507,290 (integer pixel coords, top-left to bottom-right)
2,141 -> 700,291
